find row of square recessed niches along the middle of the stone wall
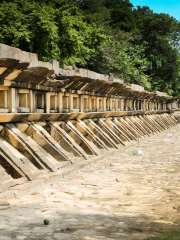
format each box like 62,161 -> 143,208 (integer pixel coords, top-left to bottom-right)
0,88 -> 172,113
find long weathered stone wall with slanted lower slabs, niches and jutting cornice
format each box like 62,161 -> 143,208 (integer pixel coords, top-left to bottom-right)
0,44 -> 180,196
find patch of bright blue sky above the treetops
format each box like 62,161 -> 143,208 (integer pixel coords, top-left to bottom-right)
130,0 -> 180,21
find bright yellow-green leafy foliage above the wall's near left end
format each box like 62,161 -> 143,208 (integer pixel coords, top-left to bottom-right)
0,0 -> 105,66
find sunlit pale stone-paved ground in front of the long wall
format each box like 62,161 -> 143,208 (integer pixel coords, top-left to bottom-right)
0,125 -> 180,240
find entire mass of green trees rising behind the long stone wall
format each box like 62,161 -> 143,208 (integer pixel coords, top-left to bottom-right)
0,0 -> 180,96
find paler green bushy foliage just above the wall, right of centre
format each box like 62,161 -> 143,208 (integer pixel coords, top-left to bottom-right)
83,29 -> 151,90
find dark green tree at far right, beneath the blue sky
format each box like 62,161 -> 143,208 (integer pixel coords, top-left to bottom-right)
133,6 -> 180,95
